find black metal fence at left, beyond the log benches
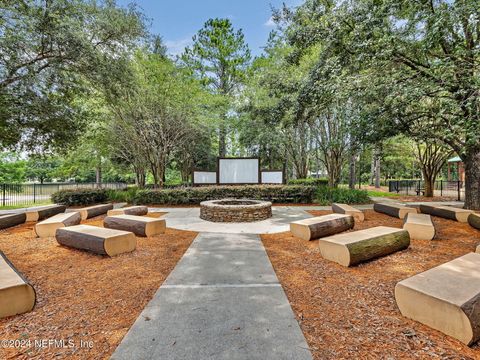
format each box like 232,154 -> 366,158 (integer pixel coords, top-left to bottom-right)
0,183 -> 127,207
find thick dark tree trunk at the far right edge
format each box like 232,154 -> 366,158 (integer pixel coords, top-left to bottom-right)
464,150 -> 480,210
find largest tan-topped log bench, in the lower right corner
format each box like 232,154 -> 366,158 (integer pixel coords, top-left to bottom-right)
395,253 -> 480,345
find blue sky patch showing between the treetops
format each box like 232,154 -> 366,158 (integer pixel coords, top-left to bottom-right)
118,0 -> 301,55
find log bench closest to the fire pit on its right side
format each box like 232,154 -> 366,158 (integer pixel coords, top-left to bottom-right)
290,214 -> 355,240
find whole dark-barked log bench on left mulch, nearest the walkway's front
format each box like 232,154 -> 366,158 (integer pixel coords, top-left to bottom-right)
55,225 -> 137,256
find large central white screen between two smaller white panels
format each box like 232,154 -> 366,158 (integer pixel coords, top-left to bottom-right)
218,158 -> 260,184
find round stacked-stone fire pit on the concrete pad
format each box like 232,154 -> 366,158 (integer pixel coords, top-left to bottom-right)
200,199 -> 272,222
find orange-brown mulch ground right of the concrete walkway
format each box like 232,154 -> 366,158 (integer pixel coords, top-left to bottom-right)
262,210 -> 480,359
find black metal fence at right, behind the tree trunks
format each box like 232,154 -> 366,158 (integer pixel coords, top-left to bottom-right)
388,180 -> 465,201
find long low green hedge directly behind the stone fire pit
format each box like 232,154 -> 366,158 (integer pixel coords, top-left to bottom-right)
132,185 -> 316,205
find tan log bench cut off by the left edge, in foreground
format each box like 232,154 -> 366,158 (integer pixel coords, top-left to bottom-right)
0,251 -> 36,318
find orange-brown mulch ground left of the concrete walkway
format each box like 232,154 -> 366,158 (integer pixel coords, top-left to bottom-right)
0,214 -> 196,359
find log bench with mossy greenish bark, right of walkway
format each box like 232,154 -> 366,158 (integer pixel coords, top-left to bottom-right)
318,226 -> 410,266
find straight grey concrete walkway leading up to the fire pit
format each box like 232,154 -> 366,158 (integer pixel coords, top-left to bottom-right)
112,232 -> 312,360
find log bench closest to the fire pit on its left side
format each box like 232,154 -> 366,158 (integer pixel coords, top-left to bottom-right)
103,215 -> 165,237
